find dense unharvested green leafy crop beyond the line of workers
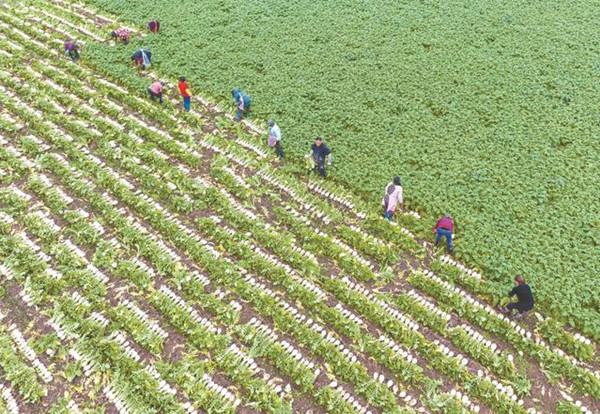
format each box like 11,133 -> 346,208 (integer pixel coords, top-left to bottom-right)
89,0 -> 600,338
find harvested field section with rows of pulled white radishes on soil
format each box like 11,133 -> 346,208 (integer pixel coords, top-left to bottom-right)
0,0 -> 600,414
